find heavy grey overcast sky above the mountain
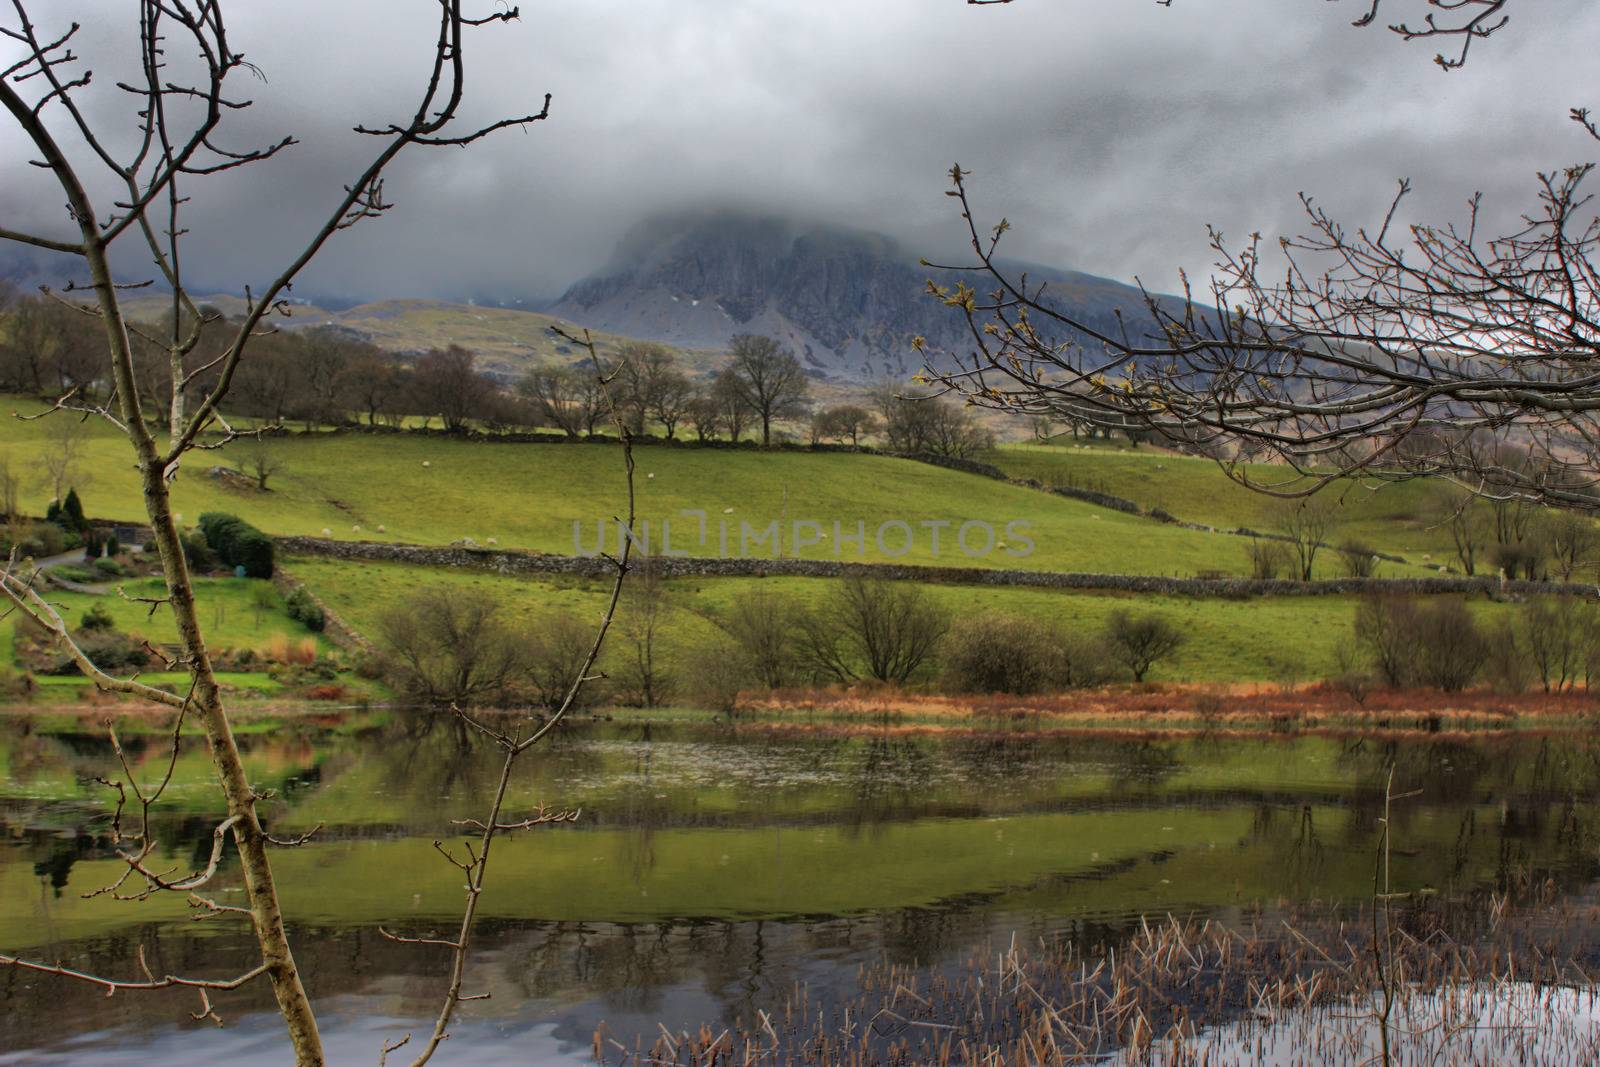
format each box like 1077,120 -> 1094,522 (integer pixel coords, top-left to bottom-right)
0,0 -> 1600,299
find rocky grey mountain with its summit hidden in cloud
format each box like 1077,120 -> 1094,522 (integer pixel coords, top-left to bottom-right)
547,213 -> 1177,381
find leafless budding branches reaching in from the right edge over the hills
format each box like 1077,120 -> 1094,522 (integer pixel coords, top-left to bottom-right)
930,166 -> 1600,509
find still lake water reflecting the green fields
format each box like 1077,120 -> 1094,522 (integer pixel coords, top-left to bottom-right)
0,715 -> 1600,1067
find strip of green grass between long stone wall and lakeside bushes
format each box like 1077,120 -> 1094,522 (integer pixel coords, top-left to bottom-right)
290,560 -> 1510,681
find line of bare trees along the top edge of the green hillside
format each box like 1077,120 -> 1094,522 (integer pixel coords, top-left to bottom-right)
0,288 -> 994,458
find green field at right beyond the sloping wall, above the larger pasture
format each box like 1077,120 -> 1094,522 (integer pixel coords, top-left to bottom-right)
982,443 -> 1454,563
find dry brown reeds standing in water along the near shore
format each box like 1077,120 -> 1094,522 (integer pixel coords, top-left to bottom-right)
590,889 -> 1600,1067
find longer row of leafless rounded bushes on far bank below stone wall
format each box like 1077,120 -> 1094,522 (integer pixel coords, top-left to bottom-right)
378,572 -> 1184,712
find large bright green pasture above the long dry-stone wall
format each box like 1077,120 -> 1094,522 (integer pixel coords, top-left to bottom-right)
0,402 -> 1427,576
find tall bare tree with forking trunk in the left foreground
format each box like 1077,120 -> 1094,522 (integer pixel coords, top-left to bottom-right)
0,0 -> 549,1067
